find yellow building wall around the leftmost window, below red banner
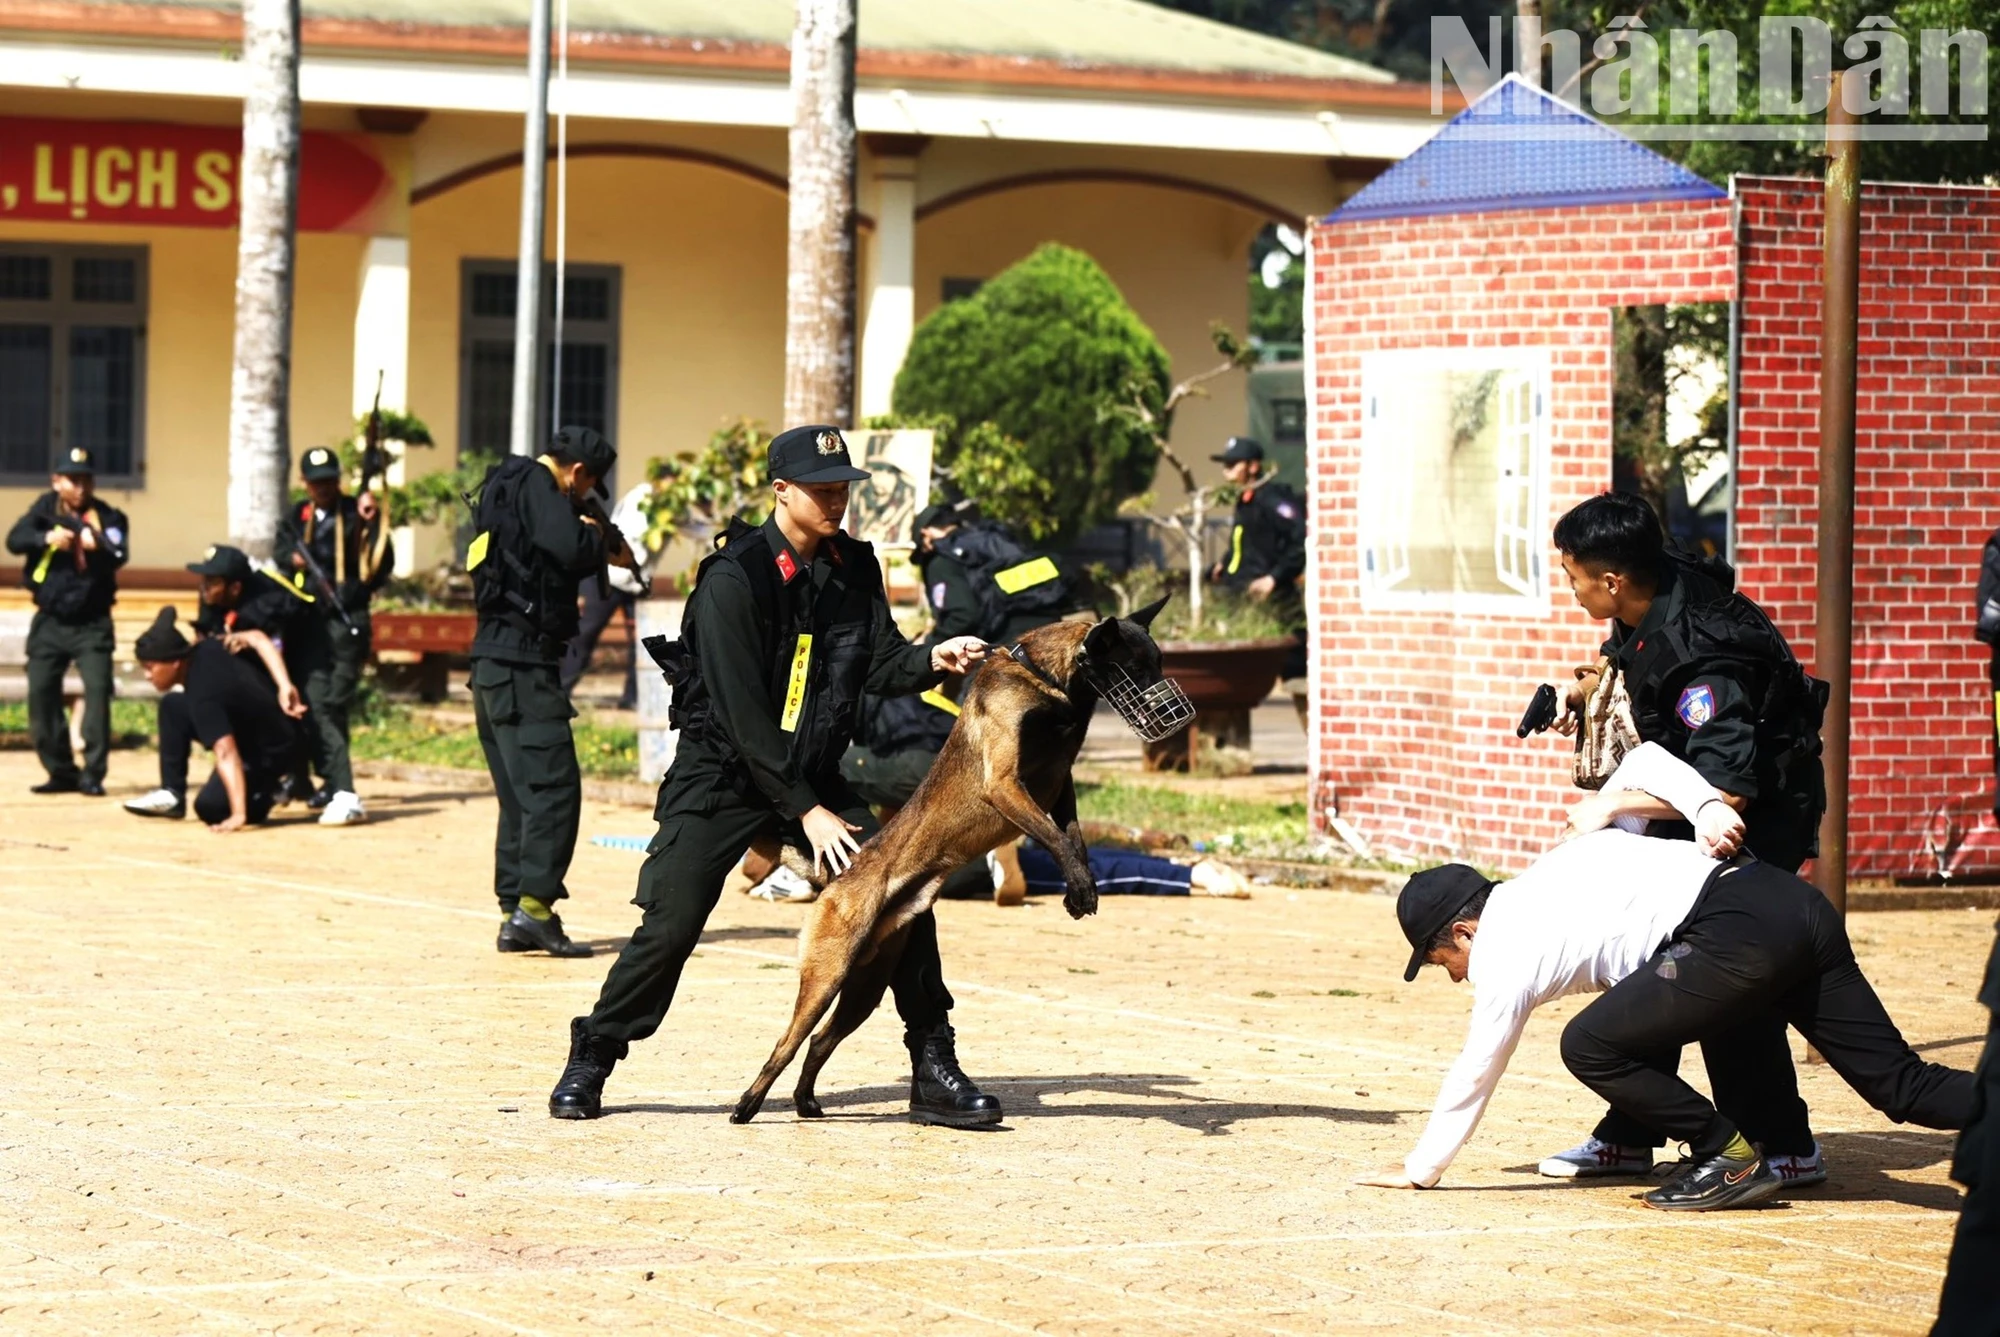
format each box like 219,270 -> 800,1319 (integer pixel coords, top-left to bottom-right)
0,222 -> 362,568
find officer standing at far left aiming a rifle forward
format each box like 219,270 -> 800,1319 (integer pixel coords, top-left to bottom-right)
6,446 -> 130,799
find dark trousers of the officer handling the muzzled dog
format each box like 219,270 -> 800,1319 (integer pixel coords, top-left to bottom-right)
584,777 -> 952,1043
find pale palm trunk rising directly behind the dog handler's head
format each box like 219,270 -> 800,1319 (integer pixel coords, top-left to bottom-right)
784,0 -> 854,426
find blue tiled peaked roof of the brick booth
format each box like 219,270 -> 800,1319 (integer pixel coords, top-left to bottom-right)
1326,74 -> 1724,222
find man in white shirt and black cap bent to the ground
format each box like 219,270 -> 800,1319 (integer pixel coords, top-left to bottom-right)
1362,743 -> 1972,1211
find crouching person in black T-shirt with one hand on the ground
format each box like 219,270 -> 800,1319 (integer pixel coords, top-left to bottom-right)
134,608 -> 304,835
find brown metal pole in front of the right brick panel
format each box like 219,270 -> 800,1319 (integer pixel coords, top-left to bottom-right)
1812,72 -> 1862,913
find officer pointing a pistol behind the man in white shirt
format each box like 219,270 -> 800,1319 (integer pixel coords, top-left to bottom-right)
1544,492 -> 1826,1187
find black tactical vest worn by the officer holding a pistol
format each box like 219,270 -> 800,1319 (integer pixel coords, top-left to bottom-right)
1626,554 -> 1828,859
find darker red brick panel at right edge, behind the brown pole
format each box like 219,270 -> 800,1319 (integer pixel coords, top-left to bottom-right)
1736,178 -> 2000,877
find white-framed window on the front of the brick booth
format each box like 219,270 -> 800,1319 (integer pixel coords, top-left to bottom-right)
1360,348 -> 1550,616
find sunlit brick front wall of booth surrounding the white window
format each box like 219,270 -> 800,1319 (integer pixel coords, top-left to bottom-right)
1308,202 -> 1728,871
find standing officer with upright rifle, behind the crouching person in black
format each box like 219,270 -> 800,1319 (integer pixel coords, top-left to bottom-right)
276,446 -> 396,827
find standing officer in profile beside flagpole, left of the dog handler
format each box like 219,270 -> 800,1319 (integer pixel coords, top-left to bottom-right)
466,426 -> 632,957
